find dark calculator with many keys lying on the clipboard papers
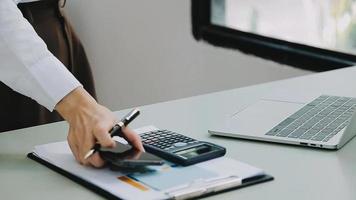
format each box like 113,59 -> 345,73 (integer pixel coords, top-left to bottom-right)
140,130 -> 226,166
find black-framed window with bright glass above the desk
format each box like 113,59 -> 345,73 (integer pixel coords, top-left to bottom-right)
192,0 -> 356,71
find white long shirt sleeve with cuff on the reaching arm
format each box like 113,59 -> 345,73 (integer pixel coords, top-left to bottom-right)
0,0 -> 81,111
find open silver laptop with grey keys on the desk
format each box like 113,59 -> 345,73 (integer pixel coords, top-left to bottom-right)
209,95 -> 356,149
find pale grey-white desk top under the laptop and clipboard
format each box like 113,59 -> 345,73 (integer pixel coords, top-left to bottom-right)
0,67 -> 356,200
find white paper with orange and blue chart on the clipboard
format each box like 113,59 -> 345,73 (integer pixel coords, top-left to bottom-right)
33,128 -> 264,200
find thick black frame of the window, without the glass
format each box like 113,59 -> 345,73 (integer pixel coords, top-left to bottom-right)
191,0 -> 356,72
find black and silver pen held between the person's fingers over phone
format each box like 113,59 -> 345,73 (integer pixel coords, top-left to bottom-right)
84,108 -> 140,159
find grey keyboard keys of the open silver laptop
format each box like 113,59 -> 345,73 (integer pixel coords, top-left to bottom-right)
266,95 -> 356,142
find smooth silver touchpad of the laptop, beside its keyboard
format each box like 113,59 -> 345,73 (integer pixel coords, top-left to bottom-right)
226,100 -> 305,135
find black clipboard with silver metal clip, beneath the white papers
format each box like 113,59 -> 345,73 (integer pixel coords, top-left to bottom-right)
27,142 -> 273,199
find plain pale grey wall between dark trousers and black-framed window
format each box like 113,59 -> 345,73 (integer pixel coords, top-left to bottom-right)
67,0 -> 309,110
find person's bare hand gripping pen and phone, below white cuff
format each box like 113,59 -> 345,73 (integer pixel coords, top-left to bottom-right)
55,87 -> 144,167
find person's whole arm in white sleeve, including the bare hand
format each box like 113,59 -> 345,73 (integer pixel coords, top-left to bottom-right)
0,0 -> 143,167
